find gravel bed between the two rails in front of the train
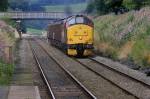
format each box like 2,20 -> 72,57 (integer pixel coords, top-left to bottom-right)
79,59 -> 150,99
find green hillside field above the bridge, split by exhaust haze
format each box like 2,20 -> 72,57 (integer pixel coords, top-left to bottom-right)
44,3 -> 87,12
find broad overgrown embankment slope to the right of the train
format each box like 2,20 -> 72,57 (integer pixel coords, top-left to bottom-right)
94,7 -> 150,72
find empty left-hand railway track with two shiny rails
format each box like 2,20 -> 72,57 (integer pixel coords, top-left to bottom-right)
29,40 -> 97,99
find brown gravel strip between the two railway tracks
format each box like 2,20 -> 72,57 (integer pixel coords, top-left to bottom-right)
37,39 -> 137,99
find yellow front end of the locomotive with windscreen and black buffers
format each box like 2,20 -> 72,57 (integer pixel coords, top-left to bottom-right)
65,15 -> 94,56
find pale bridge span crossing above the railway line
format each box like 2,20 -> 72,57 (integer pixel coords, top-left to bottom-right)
0,12 -> 83,20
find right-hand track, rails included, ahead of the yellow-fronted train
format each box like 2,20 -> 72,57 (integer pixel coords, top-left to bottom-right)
74,58 -> 150,99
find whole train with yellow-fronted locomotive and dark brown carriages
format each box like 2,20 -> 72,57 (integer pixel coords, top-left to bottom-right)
47,15 -> 94,56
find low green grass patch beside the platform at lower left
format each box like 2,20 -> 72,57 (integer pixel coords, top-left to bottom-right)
0,61 -> 14,85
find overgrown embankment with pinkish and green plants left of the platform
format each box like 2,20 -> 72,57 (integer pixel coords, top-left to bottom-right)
0,20 -> 18,85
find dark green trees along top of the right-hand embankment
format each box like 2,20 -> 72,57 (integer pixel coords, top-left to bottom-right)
87,0 -> 150,15
